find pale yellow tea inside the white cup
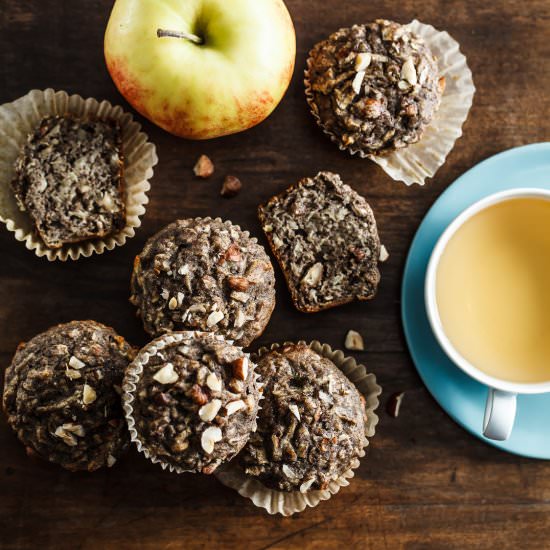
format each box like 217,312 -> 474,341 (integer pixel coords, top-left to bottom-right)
436,198 -> 550,383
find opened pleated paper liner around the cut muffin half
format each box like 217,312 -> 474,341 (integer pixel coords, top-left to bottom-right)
0,88 -> 158,261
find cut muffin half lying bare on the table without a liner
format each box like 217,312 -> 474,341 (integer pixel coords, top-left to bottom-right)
258,172 -> 380,313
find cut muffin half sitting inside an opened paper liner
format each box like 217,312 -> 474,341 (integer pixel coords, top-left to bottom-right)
11,116 -> 126,248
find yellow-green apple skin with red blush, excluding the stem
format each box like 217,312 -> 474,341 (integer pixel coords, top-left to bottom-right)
104,0 -> 296,139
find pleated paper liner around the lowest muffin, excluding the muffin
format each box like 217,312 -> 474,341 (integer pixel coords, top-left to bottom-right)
214,340 -> 382,516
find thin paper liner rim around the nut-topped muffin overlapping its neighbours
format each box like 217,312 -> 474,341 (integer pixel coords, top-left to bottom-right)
122,331 -> 262,474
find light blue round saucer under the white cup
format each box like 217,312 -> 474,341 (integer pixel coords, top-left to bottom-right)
401,143 -> 550,459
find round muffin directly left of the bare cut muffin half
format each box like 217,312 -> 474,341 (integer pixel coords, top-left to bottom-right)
130,218 -> 275,346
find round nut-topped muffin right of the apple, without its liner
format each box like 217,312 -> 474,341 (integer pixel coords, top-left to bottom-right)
306,19 -> 444,155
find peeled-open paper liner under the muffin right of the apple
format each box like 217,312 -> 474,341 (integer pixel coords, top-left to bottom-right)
304,19 -> 475,185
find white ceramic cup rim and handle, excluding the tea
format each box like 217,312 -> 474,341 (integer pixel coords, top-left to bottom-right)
430,188 -> 550,441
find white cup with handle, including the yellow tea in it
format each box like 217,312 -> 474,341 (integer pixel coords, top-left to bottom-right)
424,188 -> 550,441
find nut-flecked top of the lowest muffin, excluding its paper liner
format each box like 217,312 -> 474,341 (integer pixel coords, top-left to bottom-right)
242,344 -> 365,493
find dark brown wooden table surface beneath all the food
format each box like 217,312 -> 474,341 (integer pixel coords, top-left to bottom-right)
0,0 -> 550,549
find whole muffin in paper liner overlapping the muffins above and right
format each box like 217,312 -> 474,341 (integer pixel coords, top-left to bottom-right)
124,332 -> 260,474
